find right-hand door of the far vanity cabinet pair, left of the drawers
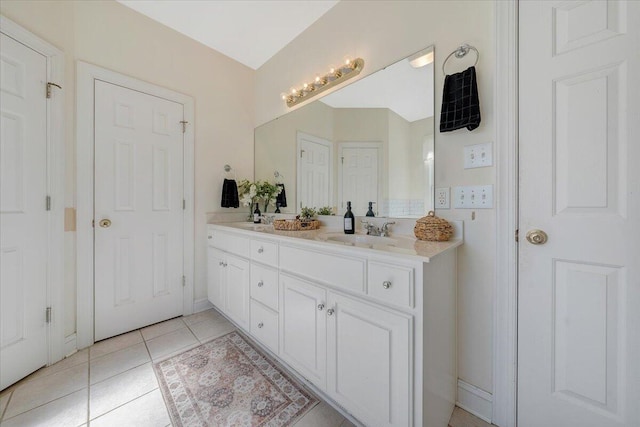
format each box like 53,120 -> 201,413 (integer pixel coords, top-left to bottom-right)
224,254 -> 249,330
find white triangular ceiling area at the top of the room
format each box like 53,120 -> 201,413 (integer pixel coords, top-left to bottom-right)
118,0 -> 339,70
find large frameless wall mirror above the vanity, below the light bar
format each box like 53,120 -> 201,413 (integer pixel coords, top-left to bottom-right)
255,47 -> 434,218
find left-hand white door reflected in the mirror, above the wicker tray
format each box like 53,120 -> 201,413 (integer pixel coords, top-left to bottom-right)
297,133 -> 332,212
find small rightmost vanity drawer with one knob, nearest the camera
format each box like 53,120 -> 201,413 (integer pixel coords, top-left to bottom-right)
367,261 -> 413,308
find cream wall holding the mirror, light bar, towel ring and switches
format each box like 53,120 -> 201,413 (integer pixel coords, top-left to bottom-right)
256,0 -> 495,398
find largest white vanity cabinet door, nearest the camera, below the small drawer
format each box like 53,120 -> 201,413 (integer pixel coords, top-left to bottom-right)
327,292 -> 413,426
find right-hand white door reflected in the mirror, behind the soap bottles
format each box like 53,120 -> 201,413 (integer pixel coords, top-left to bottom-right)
340,145 -> 379,216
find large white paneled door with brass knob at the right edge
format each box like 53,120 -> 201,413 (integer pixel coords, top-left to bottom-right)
518,1 -> 640,427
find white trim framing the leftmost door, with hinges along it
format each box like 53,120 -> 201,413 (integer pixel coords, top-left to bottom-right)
0,16 -> 66,365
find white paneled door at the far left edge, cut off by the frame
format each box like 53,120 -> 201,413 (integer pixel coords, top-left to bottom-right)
0,34 -> 48,390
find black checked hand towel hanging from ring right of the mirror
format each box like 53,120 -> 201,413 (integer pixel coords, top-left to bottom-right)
440,67 -> 480,132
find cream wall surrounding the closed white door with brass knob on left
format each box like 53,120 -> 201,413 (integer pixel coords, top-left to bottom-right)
0,0 -> 255,335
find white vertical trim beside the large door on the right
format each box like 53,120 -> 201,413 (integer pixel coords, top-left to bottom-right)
491,0 -> 518,427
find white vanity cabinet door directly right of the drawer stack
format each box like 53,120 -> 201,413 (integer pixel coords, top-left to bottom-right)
280,274 -> 327,390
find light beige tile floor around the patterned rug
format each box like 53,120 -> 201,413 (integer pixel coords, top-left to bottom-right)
0,310 -> 352,427
